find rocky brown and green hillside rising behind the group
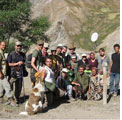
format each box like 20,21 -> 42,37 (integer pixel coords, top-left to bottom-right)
30,0 -> 120,50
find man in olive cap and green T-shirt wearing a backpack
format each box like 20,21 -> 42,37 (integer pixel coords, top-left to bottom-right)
30,40 -> 44,87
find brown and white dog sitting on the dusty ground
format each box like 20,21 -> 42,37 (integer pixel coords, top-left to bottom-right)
20,72 -> 45,115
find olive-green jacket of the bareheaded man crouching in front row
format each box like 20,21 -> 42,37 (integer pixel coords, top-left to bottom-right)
73,72 -> 90,90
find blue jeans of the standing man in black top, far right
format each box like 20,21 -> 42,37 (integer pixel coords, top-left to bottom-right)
110,72 -> 120,93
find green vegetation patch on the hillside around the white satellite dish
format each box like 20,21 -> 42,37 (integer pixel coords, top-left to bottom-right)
74,6 -> 120,50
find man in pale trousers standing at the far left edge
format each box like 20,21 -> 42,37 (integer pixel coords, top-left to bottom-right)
0,41 -> 16,105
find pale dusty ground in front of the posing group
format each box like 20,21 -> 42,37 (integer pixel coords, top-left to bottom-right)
0,74 -> 120,119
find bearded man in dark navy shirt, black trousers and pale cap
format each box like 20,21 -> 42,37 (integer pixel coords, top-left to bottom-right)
8,41 -> 26,104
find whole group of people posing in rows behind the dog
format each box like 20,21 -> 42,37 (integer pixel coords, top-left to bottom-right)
0,40 -> 120,106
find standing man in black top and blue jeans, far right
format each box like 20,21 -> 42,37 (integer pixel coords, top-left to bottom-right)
108,44 -> 120,96
